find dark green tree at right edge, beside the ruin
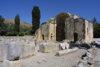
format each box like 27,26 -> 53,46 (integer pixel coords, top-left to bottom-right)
91,17 -> 100,38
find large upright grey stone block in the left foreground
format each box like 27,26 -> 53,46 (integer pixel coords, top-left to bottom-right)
7,42 -> 21,61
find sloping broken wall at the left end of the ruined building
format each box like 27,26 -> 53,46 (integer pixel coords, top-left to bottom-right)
34,22 -> 49,40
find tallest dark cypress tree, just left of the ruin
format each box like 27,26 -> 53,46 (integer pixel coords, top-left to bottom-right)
32,6 -> 40,33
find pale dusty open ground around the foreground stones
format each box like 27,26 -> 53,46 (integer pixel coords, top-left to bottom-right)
0,39 -> 100,67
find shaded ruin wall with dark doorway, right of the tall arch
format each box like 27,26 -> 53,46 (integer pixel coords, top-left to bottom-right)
65,18 -> 85,42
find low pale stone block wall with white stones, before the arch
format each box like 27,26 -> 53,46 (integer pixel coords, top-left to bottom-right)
39,41 -> 69,53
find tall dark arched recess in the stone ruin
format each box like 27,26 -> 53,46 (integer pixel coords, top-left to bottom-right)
56,12 -> 70,41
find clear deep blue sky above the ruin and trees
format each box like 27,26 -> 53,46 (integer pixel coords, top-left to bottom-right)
0,0 -> 100,24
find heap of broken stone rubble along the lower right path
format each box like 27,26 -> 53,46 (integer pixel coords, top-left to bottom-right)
75,46 -> 96,67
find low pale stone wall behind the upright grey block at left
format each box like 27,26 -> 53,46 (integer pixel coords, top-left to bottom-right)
0,37 -> 35,61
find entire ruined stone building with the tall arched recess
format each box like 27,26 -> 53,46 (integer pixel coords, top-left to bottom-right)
34,12 -> 93,43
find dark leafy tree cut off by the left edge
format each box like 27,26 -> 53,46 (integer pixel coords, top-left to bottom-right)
0,15 -> 8,35
